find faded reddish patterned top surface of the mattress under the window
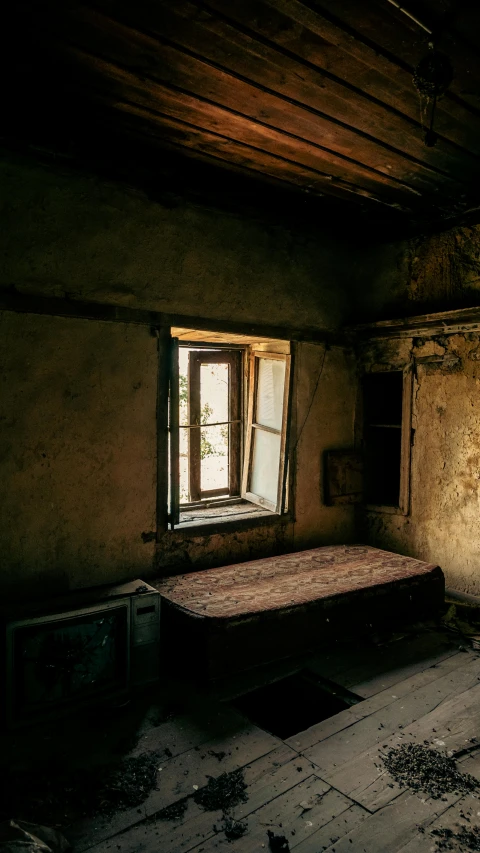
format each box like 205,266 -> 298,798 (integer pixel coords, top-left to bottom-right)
156,545 -> 443,619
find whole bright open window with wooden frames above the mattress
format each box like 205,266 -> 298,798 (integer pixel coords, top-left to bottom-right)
169,336 -> 290,527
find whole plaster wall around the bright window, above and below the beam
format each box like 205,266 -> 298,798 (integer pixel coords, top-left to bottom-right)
0,153 -> 355,596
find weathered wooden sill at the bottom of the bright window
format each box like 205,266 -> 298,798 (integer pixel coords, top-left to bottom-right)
172,501 -> 291,533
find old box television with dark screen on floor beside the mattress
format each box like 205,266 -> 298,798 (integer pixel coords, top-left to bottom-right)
4,581 -> 160,727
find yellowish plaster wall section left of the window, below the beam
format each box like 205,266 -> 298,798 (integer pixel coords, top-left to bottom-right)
0,312 -> 157,596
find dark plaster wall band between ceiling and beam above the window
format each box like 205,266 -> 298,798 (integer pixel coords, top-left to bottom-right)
0,158 -> 349,329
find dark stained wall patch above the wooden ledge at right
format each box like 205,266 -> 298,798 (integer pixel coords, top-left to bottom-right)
350,225 -> 480,322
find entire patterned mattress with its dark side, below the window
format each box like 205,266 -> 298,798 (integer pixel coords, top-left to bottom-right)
155,545 -> 445,677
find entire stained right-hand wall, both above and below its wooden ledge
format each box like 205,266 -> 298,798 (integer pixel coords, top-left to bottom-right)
351,211 -> 480,594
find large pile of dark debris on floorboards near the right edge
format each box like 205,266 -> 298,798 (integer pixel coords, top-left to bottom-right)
382,743 -> 480,799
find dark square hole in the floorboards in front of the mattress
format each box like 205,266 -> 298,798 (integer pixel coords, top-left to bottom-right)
232,670 -> 363,740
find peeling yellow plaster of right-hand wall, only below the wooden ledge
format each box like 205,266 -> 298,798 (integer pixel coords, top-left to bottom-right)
361,332 -> 480,595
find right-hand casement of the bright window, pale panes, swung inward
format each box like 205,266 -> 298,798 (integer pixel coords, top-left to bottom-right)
242,352 -> 290,512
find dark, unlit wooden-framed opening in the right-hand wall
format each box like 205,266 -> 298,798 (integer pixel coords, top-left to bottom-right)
363,371 -> 412,513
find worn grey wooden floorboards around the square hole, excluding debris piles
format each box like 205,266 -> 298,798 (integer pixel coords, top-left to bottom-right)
15,630 -> 480,853
